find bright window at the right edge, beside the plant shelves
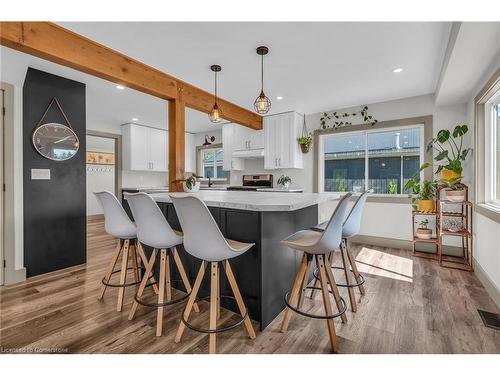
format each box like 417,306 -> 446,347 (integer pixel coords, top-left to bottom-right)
485,91 -> 500,207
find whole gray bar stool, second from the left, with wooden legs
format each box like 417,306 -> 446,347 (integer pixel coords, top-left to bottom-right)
125,193 -> 200,336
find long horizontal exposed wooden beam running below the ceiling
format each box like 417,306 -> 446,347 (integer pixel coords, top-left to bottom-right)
0,22 -> 262,129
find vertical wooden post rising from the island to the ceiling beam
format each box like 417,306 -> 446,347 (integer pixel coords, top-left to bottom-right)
167,91 -> 186,191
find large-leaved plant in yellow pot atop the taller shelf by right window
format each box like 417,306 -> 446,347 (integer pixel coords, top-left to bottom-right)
427,125 -> 472,184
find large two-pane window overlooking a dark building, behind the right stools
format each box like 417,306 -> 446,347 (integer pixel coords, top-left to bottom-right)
320,125 -> 424,194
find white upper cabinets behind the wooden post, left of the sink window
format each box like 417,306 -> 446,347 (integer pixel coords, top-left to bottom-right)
122,124 -> 196,173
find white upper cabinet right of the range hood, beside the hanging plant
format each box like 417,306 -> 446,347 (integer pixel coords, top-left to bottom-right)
264,112 -> 303,169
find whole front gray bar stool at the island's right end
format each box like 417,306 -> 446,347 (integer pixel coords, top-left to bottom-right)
281,193 -> 351,352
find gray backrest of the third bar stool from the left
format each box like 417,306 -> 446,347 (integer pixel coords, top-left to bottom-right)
170,196 -> 241,262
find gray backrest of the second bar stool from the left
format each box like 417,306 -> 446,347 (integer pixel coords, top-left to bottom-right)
125,193 -> 182,249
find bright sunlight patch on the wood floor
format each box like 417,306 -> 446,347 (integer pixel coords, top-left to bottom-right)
356,247 -> 413,283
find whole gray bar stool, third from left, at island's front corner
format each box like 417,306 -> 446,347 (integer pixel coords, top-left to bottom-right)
170,196 -> 255,354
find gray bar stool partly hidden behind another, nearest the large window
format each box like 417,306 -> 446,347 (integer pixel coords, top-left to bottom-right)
311,190 -> 371,312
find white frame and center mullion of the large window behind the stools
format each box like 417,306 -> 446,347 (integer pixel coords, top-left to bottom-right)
317,123 -> 425,197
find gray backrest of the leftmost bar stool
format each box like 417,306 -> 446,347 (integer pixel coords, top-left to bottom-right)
94,191 -> 136,239
